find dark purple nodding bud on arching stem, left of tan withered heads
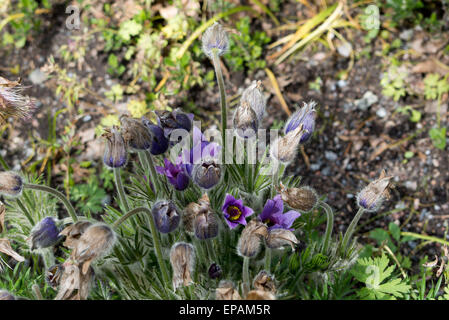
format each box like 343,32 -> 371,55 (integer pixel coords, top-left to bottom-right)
152,200 -> 181,233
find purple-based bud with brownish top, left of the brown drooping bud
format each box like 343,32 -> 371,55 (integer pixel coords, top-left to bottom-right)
102,126 -> 128,168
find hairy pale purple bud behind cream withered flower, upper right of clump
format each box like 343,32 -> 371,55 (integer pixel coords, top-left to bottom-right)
285,101 -> 316,143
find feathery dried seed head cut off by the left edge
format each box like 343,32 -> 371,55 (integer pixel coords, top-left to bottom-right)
0,77 -> 36,125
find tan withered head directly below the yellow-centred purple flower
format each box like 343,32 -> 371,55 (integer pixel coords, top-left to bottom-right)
237,219 -> 268,258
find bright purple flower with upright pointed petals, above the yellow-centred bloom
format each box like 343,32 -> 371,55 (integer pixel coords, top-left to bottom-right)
178,127 -> 221,176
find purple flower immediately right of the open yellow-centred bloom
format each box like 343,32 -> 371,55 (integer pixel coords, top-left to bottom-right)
259,194 -> 301,231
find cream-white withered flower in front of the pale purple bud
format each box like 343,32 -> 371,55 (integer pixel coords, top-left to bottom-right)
270,124 -> 305,164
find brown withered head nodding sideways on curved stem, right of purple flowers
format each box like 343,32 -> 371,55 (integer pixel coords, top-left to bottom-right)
278,183 -> 318,212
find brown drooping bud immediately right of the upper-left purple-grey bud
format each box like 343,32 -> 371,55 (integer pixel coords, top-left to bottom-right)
120,115 -> 153,150
